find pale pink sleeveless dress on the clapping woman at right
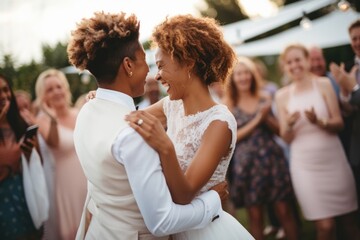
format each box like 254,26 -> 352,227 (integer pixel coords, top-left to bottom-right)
287,80 -> 358,220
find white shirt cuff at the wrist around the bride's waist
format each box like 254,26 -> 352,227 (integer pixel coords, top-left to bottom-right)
195,190 -> 223,229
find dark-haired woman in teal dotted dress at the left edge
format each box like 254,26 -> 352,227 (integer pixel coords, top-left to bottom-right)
0,75 -> 43,240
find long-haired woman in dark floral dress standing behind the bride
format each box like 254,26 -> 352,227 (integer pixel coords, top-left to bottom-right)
225,57 -> 298,240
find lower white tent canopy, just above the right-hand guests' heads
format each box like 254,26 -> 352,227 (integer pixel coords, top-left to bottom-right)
235,10 -> 360,56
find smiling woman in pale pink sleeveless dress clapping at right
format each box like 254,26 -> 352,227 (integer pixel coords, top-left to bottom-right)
275,44 -> 360,240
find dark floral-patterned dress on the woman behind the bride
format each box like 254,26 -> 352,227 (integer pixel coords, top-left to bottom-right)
229,102 -> 294,208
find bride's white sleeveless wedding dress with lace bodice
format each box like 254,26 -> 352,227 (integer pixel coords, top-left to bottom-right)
164,97 -> 254,240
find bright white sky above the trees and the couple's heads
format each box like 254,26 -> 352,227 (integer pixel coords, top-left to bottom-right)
0,0 -> 276,64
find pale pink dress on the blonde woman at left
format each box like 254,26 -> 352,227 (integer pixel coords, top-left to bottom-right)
51,125 -> 87,240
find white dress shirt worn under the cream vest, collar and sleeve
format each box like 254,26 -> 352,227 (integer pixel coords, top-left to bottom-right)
96,88 -> 222,236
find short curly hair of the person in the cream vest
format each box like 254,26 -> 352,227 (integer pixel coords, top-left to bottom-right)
67,12 -> 141,83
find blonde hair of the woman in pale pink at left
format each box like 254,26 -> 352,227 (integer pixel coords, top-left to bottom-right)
35,68 -> 72,105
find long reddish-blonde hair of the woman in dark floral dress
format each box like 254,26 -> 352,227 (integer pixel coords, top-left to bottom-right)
225,56 -> 262,107
